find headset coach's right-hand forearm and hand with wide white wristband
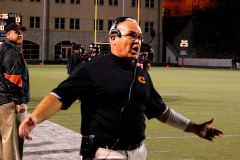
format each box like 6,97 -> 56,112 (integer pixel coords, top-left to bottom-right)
157,108 -> 223,142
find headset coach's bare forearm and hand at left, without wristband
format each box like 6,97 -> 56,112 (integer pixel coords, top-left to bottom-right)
19,94 -> 63,140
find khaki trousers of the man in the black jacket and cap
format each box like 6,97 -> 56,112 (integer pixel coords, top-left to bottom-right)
0,102 -> 25,160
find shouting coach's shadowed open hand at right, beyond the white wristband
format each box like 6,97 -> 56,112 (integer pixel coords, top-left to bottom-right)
186,118 -> 223,142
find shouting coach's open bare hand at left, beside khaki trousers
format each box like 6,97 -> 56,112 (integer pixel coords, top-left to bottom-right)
19,117 -> 37,140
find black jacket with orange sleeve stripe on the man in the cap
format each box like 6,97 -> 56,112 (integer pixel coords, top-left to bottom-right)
0,39 -> 30,105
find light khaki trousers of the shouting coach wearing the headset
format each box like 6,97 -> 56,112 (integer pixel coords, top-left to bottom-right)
94,143 -> 147,160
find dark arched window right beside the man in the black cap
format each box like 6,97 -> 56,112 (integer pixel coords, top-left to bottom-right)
22,40 -> 40,59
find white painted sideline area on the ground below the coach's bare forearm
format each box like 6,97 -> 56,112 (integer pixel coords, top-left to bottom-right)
23,115 -> 81,160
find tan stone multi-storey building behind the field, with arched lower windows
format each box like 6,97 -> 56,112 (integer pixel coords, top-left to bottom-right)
0,0 -> 162,63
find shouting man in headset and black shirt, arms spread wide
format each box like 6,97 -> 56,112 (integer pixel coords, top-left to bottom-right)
19,17 -> 223,160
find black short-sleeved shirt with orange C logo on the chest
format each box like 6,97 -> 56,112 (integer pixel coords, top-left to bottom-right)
52,54 -> 167,144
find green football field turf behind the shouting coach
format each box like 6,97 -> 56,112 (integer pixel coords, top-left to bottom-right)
28,65 -> 240,160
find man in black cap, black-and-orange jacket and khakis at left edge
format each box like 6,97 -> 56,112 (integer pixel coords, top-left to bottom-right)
0,23 -> 30,160
